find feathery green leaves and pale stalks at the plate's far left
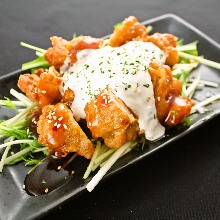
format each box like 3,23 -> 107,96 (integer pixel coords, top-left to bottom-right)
0,90 -> 48,172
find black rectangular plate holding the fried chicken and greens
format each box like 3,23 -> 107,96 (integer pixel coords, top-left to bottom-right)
0,14 -> 220,220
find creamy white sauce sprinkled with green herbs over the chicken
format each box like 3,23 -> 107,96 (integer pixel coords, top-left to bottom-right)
61,41 -> 165,140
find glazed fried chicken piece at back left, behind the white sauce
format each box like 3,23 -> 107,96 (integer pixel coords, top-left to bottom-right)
45,36 -> 103,69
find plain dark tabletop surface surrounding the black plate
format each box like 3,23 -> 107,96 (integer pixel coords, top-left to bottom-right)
0,0 -> 220,219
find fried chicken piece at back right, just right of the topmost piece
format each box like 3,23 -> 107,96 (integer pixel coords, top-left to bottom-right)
147,33 -> 179,67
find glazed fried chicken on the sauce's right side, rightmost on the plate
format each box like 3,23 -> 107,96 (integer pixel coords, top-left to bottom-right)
148,61 -> 194,126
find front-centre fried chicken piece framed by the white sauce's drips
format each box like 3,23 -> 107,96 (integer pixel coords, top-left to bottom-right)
85,88 -> 139,148
